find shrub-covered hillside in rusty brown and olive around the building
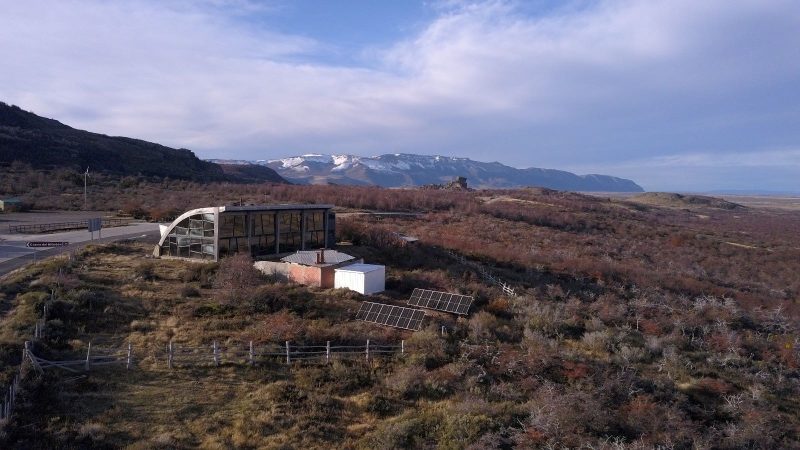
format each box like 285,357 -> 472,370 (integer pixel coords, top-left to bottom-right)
0,183 -> 800,450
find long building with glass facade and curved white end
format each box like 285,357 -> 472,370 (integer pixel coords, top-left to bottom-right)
153,205 -> 336,261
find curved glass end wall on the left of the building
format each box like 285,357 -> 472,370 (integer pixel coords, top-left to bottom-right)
161,213 -> 214,259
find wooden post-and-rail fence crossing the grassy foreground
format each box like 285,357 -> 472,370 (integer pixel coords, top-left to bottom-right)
25,339 -> 406,372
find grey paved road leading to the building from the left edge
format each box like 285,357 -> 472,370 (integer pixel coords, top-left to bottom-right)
0,223 -> 159,276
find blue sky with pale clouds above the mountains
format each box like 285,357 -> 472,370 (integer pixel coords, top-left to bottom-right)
0,0 -> 800,193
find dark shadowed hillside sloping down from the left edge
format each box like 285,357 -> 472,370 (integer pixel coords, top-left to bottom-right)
0,102 -> 285,183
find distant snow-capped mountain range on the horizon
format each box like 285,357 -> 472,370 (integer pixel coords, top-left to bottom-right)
212,153 -> 643,192
